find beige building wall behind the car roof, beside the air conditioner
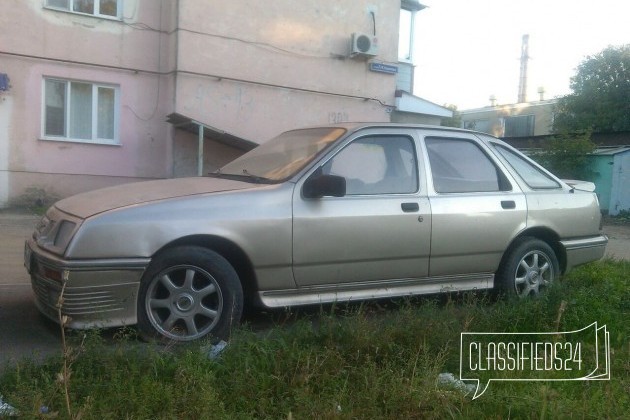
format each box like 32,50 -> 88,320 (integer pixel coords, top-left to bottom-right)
176,0 -> 400,143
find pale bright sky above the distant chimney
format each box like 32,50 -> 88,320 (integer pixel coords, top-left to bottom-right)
414,0 -> 630,110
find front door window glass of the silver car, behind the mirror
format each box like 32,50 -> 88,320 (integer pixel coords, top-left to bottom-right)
322,137 -> 418,195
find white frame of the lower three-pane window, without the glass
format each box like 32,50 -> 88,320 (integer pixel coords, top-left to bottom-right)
41,77 -> 120,145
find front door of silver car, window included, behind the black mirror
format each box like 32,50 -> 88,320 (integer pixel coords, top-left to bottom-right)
293,130 -> 431,287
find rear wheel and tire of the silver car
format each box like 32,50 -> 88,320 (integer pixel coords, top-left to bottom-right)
496,237 -> 560,298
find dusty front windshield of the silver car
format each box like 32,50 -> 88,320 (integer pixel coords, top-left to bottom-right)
216,127 -> 346,182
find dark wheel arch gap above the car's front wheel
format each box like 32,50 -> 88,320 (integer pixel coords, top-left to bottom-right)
154,235 -> 259,305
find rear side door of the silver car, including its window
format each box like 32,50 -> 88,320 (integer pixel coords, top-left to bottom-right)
423,132 -> 527,277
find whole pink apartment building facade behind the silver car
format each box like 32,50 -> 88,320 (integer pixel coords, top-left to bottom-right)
0,0 -> 450,206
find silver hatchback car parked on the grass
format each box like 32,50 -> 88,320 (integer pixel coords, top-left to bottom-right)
25,124 -> 608,341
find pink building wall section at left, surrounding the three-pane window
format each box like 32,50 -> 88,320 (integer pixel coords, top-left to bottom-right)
0,0 -> 174,205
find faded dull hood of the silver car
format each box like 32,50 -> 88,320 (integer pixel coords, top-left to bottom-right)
55,177 -> 260,219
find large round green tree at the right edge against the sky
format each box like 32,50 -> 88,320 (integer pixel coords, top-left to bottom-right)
553,44 -> 630,133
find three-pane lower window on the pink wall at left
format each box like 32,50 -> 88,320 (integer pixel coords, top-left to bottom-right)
43,79 -> 119,144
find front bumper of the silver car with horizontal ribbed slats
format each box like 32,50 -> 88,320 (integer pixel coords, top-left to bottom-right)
24,239 -> 150,329
